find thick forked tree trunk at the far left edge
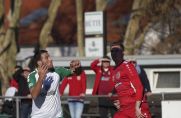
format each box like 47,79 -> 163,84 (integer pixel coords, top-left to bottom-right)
0,0 -> 21,94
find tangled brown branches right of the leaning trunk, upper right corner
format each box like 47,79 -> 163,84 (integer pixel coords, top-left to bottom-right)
139,0 -> 181,54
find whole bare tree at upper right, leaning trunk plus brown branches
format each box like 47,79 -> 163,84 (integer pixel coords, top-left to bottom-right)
124,0 -> 181,54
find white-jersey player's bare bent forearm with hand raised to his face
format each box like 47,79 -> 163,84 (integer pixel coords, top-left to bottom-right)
29,65 -> 48,99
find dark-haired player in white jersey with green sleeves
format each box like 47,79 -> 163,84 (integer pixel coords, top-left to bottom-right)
28,50 -> 78,118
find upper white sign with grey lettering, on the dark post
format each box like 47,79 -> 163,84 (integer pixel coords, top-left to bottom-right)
84,12 -> 103,35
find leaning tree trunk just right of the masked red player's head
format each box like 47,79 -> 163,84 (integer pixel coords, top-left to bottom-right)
124,0 -> 149,55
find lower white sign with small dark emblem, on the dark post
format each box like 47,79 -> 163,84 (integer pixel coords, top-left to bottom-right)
85,37 -> 103,57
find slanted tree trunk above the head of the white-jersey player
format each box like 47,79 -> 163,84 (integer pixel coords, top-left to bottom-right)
39,0 -> 61,48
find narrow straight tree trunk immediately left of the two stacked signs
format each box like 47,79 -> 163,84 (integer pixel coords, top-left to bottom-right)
76,0 -> 84,57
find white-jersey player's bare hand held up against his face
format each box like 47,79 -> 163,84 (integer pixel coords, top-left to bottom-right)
38,63 -> 48,80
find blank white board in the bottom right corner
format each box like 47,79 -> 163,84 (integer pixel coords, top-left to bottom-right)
161,101 -> 181,118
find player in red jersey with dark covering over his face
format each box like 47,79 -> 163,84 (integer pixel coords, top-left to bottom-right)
111,42 -> 145,118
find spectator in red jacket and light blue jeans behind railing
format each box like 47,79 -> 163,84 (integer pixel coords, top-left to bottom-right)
60,60 -> 86,118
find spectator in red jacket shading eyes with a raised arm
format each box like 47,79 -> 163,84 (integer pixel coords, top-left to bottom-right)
91,56 -> 115,118
